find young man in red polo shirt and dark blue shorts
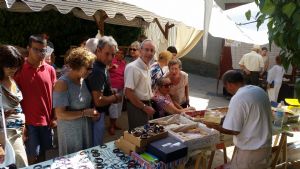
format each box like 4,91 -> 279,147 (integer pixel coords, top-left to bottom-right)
15,35 -> 56,164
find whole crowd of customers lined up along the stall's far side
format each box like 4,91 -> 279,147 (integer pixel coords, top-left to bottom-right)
0,35 -> 194,168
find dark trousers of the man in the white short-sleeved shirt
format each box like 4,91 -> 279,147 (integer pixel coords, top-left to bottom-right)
126,100 -> 149,130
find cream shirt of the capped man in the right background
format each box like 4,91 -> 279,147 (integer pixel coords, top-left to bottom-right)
239,51 -> 265,71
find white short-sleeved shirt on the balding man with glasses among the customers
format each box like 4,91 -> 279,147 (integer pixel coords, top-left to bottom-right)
124,57 -> 153,100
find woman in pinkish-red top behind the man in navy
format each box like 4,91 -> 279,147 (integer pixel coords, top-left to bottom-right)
108,48 -> 126,135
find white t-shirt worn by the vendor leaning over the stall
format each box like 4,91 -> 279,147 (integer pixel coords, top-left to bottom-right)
223,85 -> 272,150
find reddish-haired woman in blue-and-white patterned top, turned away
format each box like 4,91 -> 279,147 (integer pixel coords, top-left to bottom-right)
150,51 -> 172,89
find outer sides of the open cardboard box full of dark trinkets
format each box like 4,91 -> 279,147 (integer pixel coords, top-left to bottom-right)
124,131 -> 168,148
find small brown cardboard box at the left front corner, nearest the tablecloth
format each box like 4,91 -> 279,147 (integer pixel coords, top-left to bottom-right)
115,136 -> 144,155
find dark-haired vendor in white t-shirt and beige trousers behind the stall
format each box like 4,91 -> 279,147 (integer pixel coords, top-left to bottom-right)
209,70 -> 272,169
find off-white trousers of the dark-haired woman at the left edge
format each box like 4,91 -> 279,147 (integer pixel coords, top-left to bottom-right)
7,129 -> 28,168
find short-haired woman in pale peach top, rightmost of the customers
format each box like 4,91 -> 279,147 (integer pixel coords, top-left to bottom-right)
166,59 -> 189,108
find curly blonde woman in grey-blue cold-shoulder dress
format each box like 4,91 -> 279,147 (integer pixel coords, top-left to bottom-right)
53,47 -> 99,156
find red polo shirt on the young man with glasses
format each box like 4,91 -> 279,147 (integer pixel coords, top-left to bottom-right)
15,61 -> 56,126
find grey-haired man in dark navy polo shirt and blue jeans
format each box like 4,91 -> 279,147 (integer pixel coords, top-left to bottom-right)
87,36 -> 122,146
